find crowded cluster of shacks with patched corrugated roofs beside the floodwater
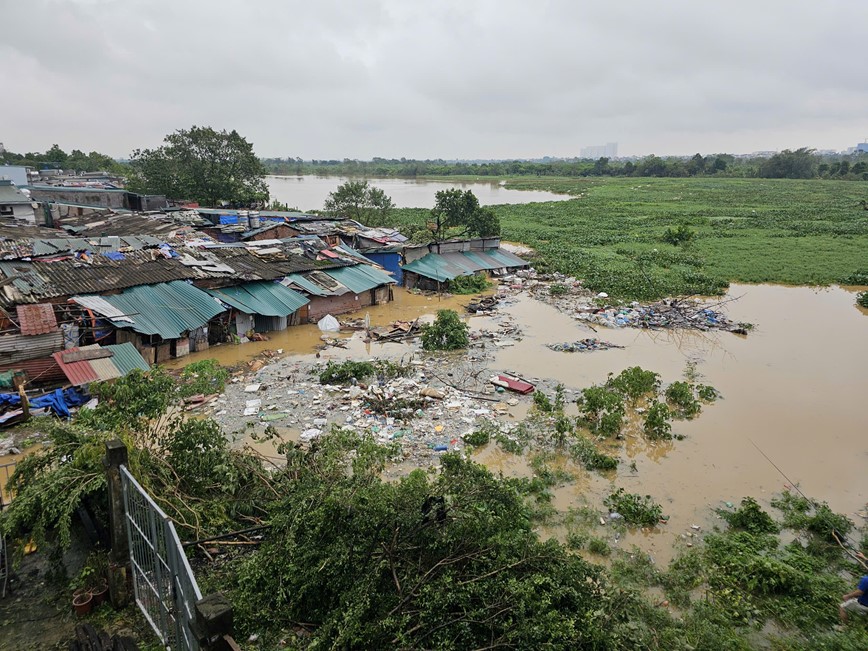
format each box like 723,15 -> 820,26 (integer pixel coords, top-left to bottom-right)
0,204 -> 526,386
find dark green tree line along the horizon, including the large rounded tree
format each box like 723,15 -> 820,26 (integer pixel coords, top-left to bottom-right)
0,125 -> 868,206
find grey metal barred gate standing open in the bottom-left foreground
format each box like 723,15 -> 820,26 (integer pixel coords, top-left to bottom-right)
120,466 -> 202,651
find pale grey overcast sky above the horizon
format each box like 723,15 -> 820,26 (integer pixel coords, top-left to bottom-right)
0,0 -> 868,159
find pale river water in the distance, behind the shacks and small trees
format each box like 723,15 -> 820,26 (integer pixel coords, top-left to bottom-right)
265,176 -> 571,210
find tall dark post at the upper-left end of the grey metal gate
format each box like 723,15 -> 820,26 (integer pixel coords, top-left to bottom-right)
103,439 -> 130,608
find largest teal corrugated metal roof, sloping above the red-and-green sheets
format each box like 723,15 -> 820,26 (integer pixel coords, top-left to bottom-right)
102,280 -> 225,339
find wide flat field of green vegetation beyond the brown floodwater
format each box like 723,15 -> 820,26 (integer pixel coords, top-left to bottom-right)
394,177 -> 868,299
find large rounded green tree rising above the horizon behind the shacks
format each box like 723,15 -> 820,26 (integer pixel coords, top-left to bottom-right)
129,126 -> 268,206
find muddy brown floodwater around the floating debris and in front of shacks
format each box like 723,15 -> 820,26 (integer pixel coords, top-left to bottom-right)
173,285 -> 868,561
